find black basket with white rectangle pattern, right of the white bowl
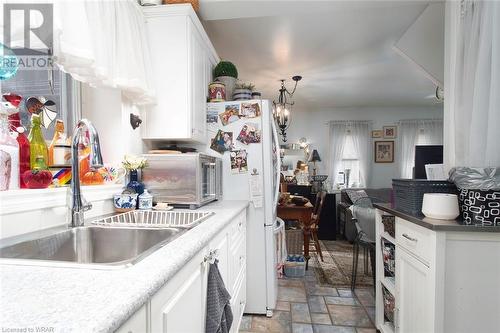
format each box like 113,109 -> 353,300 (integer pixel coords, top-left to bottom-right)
458,188 -> 500,227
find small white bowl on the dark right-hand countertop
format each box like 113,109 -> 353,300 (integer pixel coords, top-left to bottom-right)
422,193 -> 460,220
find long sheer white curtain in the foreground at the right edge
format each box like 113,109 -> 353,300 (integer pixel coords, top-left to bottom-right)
448,0 -> 500,167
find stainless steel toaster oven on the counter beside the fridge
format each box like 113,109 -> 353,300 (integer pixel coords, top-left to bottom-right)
142,153 -> 222,209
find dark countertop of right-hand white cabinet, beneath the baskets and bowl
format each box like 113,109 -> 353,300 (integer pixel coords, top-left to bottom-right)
373,203 -> 500,233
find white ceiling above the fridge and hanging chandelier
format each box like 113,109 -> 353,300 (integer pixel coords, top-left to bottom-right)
200,0 -> 444,110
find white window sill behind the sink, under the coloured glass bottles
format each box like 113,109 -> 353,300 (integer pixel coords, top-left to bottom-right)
0,184 -> 123,215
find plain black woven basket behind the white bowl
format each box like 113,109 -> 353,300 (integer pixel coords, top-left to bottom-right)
392,179 -> 458,215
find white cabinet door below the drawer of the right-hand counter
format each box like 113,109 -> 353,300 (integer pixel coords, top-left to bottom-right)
396,246 -> 435,333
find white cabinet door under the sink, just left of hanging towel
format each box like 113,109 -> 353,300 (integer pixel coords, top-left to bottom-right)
151,251 -> 207,333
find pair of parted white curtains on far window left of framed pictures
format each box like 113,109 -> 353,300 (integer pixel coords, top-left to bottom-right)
329,121 -> 372,187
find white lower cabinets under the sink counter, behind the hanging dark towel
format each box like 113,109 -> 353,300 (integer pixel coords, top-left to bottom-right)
118,211 -> 246,333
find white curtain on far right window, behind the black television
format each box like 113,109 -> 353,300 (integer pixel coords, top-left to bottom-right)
398,119 -> 443,178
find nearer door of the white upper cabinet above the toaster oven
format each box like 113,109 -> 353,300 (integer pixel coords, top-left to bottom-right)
189,22 -> 208,142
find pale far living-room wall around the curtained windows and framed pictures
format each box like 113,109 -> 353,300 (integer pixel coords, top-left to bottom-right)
287,106 -> 443,188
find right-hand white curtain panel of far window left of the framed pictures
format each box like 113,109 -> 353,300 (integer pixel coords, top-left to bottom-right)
349,121 -> 372,187
